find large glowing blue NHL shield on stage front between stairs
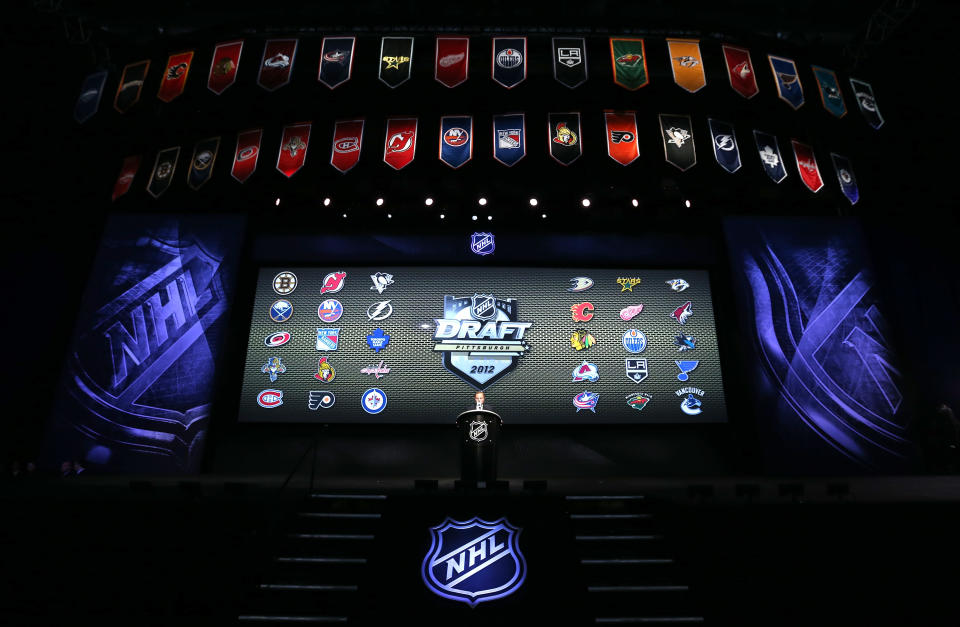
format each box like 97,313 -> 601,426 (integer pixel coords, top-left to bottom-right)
421,518 -> 527,607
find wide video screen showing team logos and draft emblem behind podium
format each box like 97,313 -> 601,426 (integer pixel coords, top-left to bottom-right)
240,266 -> 726,424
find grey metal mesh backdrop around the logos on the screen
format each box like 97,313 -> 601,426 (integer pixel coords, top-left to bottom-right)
240,266 -> 727,424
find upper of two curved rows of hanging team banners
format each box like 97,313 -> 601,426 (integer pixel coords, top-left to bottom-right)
74,36 -> 883,128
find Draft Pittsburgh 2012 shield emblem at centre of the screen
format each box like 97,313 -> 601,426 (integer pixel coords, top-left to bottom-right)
433,294 -> 532,390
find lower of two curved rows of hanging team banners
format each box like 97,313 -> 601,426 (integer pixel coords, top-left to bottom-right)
113,116 -> 860,204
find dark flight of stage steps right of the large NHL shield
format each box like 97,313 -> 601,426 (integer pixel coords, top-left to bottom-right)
564,495 -> 704,625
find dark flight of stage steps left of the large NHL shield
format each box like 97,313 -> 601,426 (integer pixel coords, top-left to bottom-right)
237,493 -> 386,625
